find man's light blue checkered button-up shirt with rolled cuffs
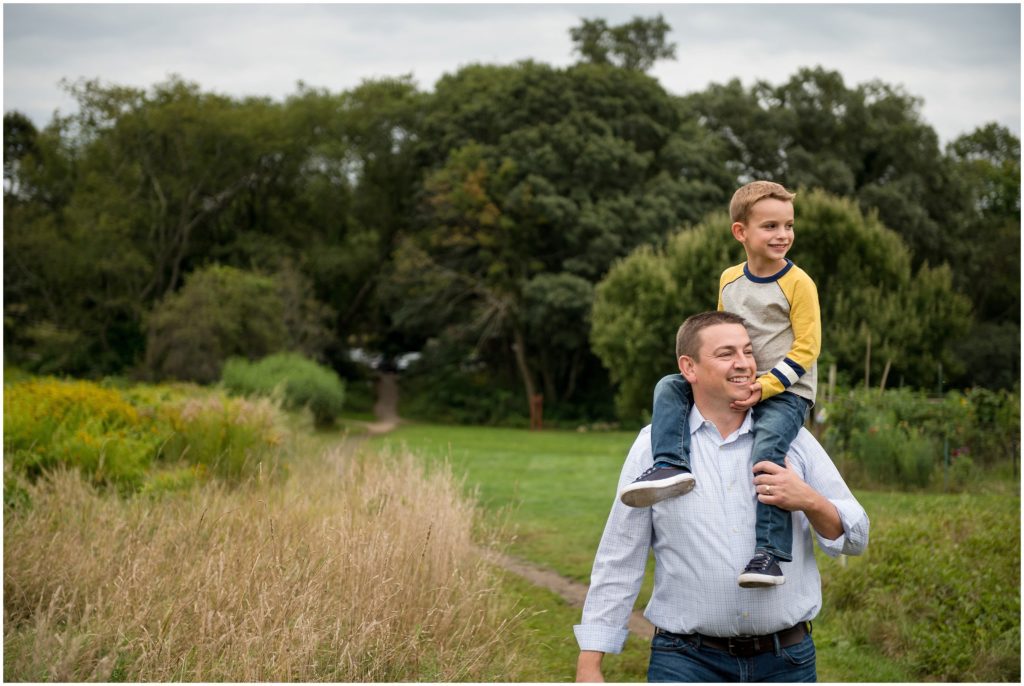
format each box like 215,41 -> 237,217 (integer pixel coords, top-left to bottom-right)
574,406 -> 868,653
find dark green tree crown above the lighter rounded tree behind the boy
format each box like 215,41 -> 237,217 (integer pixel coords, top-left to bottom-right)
684,67 -> 963,274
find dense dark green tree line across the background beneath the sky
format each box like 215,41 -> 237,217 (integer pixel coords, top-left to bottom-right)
4,26 -> 1020,403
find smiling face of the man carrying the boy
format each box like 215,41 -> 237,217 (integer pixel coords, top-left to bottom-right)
680,324 -> 757,402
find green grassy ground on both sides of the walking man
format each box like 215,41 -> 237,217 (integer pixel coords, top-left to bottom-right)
372,424 -> 1020,682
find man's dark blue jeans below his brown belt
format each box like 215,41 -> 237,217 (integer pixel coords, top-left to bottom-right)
647,634 -> 818,683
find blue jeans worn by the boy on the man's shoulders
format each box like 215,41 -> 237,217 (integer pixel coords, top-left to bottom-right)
650,374 -> 811,562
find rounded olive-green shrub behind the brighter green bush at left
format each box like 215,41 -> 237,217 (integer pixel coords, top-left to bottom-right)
146,266 -> 287,383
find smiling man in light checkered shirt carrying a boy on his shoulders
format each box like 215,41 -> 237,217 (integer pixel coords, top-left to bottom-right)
575,311 -> 868,682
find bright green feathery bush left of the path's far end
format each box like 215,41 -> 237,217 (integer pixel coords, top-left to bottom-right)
221,352 -> 345,427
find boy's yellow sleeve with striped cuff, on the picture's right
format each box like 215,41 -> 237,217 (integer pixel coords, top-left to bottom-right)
758,271 -> 821,400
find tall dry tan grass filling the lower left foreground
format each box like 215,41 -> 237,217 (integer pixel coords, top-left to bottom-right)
3,446 -> 516,682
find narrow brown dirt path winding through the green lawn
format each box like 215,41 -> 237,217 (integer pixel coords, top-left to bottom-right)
345,373 -> 654,639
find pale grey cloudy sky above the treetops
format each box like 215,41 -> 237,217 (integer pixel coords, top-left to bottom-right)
3,2 -> 1021,142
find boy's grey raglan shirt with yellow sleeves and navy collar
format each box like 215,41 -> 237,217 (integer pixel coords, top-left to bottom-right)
718,260 -> 821,402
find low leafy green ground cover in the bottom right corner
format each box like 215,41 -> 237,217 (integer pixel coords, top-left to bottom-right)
827,494 -> 1021,682
